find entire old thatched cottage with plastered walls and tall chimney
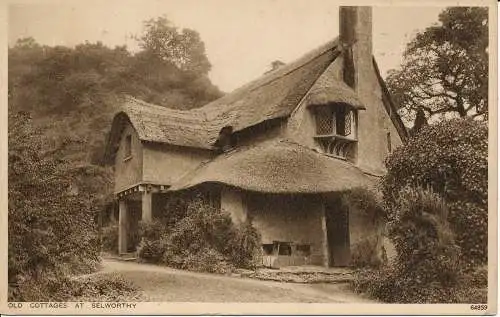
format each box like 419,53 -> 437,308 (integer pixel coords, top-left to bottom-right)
106,7 -> 407,266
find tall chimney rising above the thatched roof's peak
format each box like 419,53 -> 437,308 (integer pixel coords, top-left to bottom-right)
339,6 -> 373,94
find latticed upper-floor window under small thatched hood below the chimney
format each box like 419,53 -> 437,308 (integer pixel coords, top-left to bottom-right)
312,103 -> 358,160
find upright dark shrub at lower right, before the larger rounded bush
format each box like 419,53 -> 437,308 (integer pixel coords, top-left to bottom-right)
353,187 -> 466,303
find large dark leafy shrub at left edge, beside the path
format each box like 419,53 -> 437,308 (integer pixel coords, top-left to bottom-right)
8,113 -> 99,285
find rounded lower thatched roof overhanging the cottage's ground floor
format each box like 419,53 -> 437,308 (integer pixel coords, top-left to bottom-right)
169,140 -> 373,193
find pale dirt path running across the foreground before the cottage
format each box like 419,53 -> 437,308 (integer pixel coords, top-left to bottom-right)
101,259 -> 372,303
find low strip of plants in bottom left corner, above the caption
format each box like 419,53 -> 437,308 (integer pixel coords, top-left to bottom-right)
9,274 -> 141,302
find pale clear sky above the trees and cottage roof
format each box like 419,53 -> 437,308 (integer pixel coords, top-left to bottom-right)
8,0 -> 444,92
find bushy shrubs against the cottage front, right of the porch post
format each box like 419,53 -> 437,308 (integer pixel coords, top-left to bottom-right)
138,197 -> 260,273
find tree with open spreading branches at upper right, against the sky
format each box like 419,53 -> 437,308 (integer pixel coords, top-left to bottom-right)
387,7 -> 488,121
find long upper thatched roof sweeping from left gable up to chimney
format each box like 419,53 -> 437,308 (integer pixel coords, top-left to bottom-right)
107,40 -> 339,155
